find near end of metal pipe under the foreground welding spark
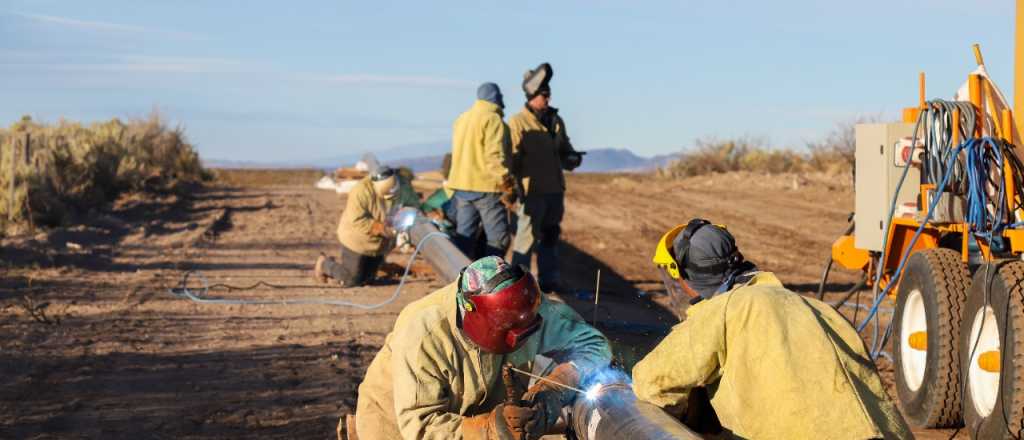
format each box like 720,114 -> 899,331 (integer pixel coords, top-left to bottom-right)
570,383 -> 701,440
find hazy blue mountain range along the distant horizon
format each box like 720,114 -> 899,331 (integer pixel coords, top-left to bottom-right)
203,141 -> 678,173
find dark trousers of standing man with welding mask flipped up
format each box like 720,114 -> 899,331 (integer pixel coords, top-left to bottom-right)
512,192 -> 565,287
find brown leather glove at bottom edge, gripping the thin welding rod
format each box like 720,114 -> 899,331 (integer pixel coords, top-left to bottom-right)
462,403 -> 543,440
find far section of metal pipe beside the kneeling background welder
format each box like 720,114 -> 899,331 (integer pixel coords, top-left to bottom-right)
391,208 -> 470,282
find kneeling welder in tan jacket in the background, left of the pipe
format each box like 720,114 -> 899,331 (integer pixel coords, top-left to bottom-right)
313,166 -> 420,287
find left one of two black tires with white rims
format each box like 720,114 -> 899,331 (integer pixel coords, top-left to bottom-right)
893,248 -> 971,428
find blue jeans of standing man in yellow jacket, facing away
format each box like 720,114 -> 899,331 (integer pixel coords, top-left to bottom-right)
452,190 -> 510,260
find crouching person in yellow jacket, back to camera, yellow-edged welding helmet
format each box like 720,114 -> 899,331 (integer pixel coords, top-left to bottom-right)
633,219 -> 912,439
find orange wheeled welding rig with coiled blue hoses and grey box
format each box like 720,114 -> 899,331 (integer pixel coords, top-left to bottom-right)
819,0 -> 1024,439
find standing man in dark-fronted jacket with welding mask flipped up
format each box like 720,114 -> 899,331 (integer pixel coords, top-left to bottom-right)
509,62 -> 584,292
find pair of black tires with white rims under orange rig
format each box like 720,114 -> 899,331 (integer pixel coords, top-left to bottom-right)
893,249 -> 1024,439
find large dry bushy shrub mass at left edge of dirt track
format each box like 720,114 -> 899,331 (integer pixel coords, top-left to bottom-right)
0,115 -> 209,230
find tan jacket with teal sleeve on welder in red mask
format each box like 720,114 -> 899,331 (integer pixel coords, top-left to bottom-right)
356,282 -> 611,440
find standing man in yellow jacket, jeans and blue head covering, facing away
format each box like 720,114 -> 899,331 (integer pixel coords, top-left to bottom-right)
447,83 -> 512,259
